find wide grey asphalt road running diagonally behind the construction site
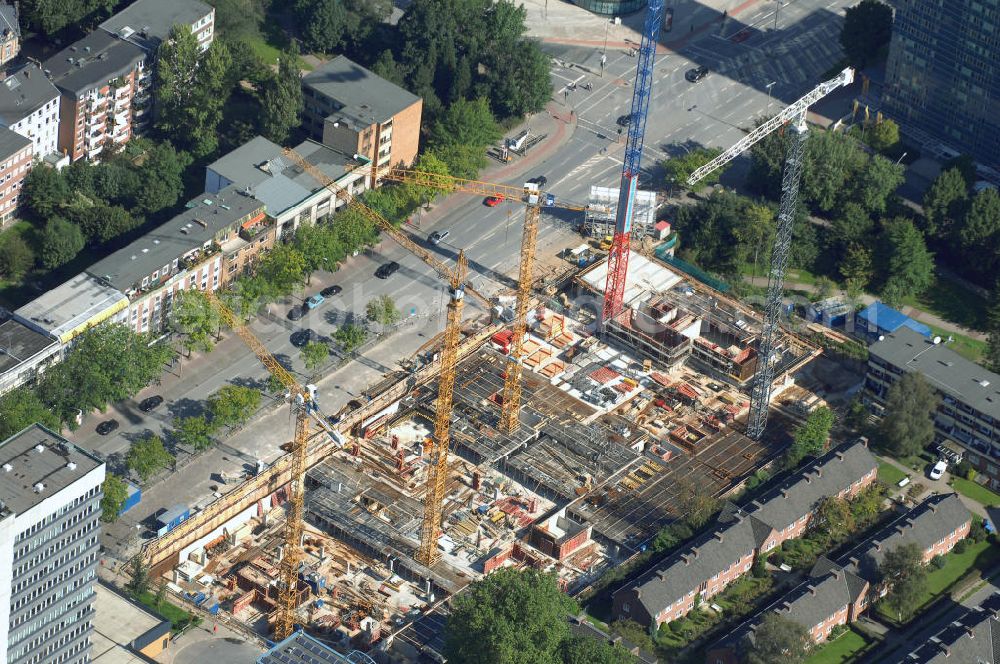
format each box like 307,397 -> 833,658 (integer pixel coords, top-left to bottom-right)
97,0 -> 850,556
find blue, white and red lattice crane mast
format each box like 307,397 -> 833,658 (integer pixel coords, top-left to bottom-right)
601,0 -> 663,325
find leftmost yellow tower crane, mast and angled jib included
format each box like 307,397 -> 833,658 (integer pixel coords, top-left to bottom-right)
205,291 -> 314,640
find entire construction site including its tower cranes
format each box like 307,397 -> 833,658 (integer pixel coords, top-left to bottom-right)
133,49 -> 851,661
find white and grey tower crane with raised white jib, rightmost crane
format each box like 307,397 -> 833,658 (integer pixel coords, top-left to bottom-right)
687,68 -> 854,440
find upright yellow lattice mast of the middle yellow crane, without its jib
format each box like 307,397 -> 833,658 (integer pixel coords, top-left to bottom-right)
416,252 -> 468,567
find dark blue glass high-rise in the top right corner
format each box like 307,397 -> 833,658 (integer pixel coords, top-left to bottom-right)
883,0 -> 1000,165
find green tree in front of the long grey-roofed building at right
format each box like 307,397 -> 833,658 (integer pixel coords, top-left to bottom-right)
879,371 -> 938,457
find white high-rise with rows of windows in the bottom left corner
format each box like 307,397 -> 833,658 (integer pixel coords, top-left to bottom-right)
0,424 -> 104,664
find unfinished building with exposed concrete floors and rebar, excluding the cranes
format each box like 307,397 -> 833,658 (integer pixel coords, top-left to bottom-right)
133,259 -> 810,651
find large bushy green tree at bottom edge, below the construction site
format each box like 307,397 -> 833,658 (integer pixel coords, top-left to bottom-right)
444,568 -> 578,664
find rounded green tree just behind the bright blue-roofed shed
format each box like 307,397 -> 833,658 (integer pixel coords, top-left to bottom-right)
883,217 -> 934,306
